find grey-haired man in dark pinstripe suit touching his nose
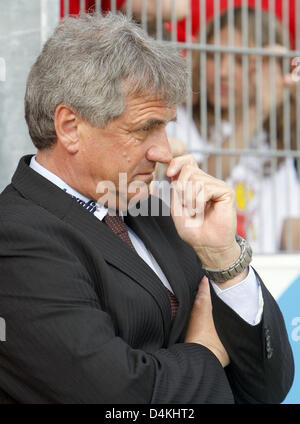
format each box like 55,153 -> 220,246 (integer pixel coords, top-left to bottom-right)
0,14 -> 293,403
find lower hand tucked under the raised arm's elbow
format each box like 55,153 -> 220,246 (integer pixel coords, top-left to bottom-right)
184,277 -> 230,368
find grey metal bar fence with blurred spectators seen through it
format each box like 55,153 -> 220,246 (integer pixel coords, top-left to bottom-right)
29,0 -> 300,253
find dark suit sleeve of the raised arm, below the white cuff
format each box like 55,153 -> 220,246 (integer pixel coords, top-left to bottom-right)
211,274 -> 294,404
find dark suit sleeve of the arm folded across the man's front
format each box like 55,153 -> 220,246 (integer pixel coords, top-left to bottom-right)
0,222 -> 233,404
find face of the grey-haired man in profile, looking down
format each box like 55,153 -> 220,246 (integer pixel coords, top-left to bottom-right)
77,96 -> 176,209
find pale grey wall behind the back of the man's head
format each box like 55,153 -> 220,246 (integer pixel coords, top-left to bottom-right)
0,0 -> 59,191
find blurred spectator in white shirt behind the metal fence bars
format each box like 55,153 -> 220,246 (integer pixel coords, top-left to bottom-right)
167,8 -> 300,253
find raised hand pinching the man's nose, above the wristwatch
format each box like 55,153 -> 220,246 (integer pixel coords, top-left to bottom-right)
167,155 -> 241,272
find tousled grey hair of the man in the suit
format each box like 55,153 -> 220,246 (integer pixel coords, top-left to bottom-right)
25,13 -> 188,149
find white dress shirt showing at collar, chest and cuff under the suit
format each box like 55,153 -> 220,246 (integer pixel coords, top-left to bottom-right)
30,156 -> 263,325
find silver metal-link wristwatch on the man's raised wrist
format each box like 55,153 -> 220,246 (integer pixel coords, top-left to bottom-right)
203,236 -> 252,282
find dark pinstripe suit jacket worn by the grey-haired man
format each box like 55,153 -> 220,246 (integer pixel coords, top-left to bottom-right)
0,156 -> 294,403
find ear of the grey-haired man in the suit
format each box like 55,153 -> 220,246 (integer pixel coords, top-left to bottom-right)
54,104 -> 79,154
